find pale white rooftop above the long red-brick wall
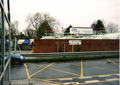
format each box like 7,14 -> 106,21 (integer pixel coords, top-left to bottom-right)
41,33 -> 120,39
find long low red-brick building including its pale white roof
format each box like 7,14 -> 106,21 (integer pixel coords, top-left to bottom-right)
34,33 -> 120,53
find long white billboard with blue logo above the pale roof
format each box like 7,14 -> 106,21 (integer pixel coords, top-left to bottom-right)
70,28 -> 93,34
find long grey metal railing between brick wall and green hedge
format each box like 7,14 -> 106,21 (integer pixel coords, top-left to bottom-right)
21,51 -> 119,57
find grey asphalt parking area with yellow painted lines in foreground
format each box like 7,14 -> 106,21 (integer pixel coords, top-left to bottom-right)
11,58 -> 119,85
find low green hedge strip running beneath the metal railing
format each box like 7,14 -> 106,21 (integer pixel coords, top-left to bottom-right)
25,55 -> 119,63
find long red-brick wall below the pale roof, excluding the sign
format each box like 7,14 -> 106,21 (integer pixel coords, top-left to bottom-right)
34,39 -> 119,53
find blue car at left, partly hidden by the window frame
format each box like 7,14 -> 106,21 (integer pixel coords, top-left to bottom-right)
5,53 -> 25,65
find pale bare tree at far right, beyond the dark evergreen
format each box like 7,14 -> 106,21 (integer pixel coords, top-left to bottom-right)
105,22 -> 120,33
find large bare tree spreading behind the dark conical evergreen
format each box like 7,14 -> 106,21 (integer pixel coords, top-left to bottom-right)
26,13 -> 60,37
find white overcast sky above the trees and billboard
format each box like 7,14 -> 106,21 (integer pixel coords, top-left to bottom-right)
10,0 -> 120,31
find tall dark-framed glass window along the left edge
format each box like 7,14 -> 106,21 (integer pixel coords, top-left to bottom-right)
0,0 -> 11,85
